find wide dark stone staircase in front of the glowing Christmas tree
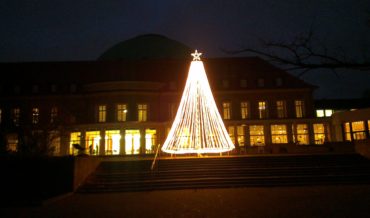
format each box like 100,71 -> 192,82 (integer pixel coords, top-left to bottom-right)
77,154 -> 370,193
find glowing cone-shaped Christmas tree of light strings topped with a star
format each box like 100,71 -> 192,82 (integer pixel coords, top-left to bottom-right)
162,50 -> 234,154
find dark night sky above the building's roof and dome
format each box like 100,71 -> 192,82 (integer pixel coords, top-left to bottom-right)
0,0 -> 370,98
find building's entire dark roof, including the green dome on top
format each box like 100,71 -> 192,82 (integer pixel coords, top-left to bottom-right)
0,34 -> 314,94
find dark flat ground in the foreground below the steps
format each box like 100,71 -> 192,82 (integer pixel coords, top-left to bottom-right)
0,185 -> 370,218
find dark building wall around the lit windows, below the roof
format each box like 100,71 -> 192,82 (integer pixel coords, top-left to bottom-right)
1,79 -> 328,155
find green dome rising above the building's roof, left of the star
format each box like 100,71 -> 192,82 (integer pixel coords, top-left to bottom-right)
98,34 -> 192,60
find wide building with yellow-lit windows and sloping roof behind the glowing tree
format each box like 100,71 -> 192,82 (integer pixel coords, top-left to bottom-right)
0,36 -> 342,155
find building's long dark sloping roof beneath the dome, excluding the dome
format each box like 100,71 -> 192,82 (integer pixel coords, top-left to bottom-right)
0,57 -> 314,89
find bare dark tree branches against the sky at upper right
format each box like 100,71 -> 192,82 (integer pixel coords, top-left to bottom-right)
223,30 -> 370,76
